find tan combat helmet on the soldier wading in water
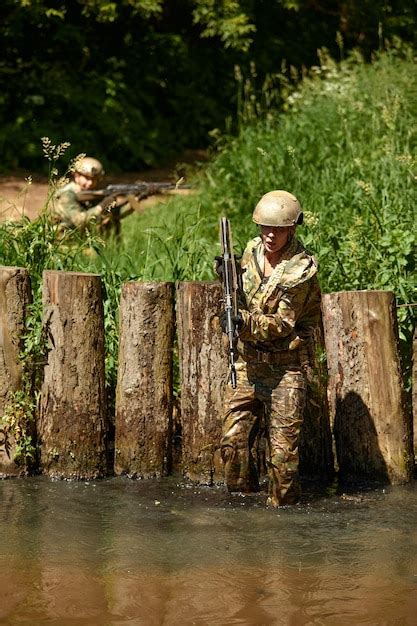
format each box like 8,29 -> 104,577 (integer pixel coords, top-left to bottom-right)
252,189 -> 303,227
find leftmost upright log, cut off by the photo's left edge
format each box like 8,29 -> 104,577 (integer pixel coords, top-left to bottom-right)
0,267 -> 34,476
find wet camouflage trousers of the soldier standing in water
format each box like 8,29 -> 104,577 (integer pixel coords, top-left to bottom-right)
221,361 -> 306,507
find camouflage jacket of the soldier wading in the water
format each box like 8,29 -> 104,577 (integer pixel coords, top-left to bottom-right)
239,237 -> 320,355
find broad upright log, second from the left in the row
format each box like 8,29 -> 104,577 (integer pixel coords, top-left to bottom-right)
38,271 -> 107,479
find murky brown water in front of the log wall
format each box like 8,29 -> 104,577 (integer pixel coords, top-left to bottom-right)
0,477 -> 417,626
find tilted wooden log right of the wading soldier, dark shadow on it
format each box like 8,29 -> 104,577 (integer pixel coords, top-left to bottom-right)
322,291 -> 413,484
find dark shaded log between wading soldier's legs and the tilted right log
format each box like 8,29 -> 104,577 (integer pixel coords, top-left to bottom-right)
299,324 -> 335,480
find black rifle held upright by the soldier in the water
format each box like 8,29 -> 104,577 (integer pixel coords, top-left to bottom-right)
220,217 -> 239,389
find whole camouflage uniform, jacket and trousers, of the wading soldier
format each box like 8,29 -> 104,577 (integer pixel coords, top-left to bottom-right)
221,237 -> 320,506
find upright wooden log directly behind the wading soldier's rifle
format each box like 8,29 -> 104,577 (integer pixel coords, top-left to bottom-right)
177,282 -> 228,484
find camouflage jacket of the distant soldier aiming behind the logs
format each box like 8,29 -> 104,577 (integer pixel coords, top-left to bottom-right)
52,182 -> 101,228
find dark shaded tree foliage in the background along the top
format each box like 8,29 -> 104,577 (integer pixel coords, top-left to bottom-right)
0,0 -> 416,172
